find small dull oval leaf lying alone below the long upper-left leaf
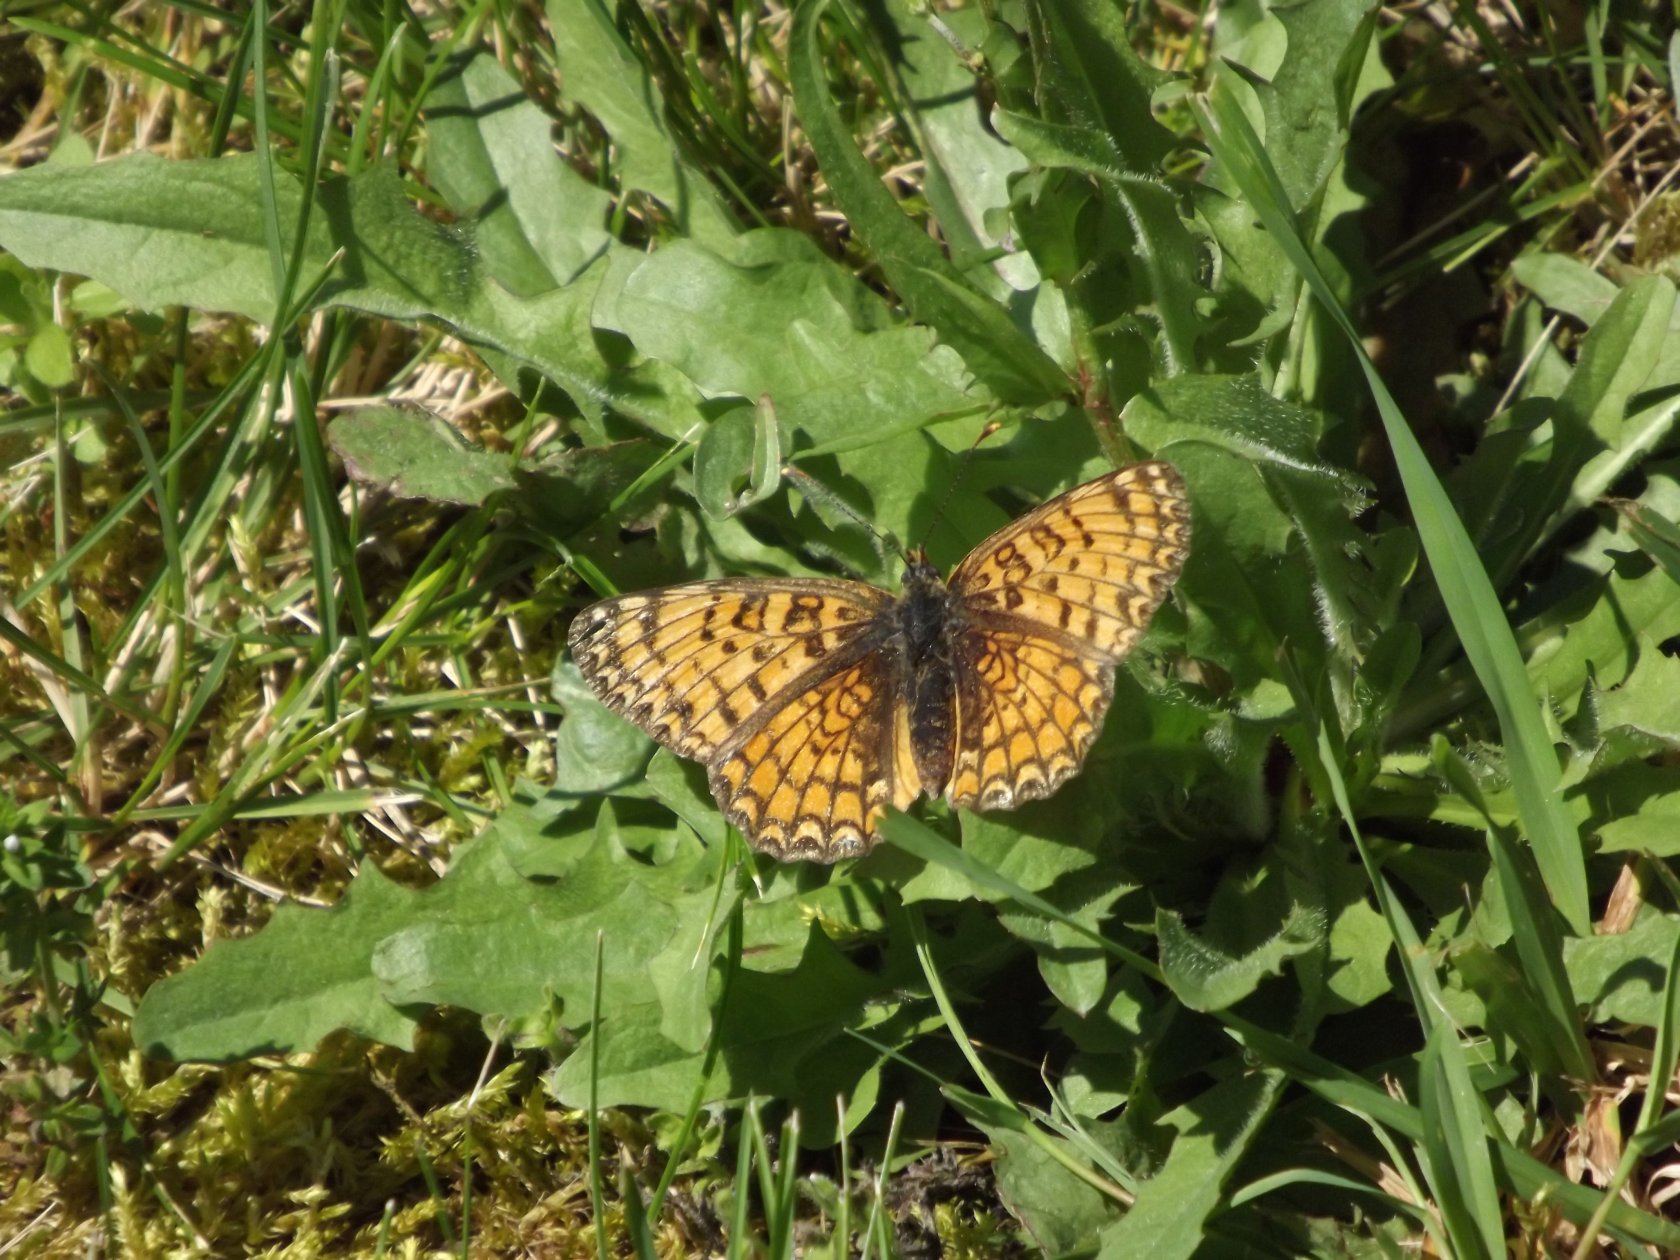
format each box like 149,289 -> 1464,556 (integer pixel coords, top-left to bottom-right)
326,407 -> 514,504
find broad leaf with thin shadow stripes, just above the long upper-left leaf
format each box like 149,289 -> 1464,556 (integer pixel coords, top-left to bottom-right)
425,49 -> 612,296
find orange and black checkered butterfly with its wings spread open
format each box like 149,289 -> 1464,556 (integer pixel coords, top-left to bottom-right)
568,460 -> 1189,862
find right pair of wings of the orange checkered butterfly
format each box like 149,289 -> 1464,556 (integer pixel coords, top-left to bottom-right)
946,460 -> 1189,808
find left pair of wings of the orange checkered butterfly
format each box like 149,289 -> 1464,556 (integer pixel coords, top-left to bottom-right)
570,580 -> 921,862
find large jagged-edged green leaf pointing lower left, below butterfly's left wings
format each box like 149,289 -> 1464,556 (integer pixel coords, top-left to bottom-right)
136,806 -> 727,1058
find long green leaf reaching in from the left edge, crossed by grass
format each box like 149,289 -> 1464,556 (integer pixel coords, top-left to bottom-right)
0,153 -> 704,437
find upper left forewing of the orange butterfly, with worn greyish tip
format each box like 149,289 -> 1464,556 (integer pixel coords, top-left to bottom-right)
570,578 -> 892,763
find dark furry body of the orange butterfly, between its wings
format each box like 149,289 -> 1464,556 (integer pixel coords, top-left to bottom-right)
894,551 -> 961,795
